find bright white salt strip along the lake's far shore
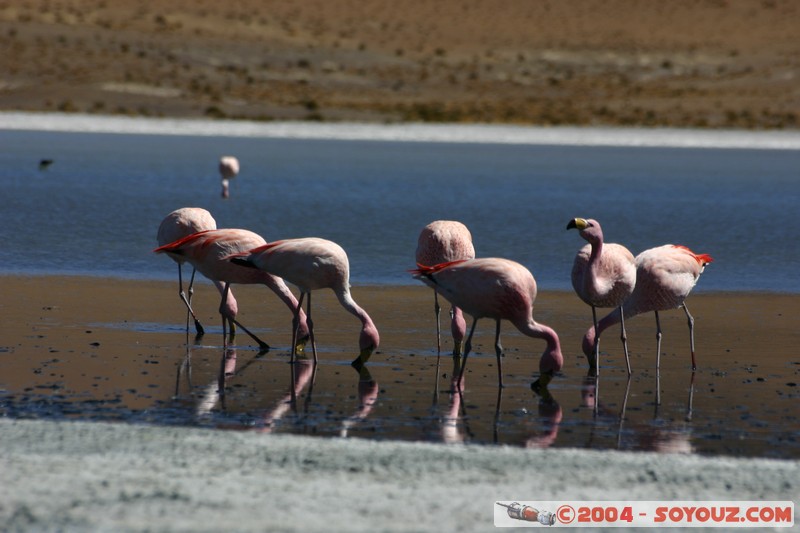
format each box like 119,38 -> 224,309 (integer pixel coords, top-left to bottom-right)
0,111 -> 800,150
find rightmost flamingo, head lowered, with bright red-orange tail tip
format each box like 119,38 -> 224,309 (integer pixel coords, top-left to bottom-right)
583,244 -> 713,370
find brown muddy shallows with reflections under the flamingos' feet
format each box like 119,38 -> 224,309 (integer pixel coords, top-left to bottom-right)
0,278 -> 800,459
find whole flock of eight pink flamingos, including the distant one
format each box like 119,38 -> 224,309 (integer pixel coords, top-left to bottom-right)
154,156 -> 713,397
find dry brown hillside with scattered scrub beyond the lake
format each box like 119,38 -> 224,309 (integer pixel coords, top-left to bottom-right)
0,0 -> 800,128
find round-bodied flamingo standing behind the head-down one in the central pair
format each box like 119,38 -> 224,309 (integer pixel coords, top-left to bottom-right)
417,220 -> 475,355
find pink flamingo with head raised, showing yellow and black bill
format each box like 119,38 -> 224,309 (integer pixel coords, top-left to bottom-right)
567,218 -> 636,375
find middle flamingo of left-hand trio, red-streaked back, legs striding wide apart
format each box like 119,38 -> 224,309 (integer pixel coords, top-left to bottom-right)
153,229 -> 308,353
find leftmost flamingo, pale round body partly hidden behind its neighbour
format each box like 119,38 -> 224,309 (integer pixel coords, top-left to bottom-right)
156,207 -> 217,336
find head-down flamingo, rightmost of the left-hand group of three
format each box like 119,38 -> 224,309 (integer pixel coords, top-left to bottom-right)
230,237 -> 380,369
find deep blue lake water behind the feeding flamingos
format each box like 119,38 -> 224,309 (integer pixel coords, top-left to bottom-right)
0,124 -> 800,292
